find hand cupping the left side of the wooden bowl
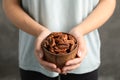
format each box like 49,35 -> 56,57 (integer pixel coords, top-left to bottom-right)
35,29 -> 61,73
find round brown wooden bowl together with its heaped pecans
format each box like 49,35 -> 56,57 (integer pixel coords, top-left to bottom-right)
41,32 -> 78,68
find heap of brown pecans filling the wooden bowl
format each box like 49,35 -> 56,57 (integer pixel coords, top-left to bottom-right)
42,32 -> 77,54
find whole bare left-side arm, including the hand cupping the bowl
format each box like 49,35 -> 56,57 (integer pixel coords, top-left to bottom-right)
3,0 -> 60,72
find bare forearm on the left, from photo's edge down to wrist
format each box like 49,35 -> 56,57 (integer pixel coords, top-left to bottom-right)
3,0 -> 45,36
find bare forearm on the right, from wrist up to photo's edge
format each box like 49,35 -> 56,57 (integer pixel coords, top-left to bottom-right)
76,0 -> 116,35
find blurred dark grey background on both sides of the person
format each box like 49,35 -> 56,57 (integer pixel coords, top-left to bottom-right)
0,0 -> 120,80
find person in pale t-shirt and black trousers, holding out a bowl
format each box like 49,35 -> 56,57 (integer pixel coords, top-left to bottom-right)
3,0 -> 116,80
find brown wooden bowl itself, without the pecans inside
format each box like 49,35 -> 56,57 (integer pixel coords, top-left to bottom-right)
41,32 -> 78,68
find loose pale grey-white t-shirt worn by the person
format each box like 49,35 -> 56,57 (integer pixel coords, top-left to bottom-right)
19,0 -> 100,77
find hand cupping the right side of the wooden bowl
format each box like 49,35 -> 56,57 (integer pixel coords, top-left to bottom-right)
62,28 -> 87,74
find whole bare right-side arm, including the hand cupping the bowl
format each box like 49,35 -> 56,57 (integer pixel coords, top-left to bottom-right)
62,0 -> 116,73
